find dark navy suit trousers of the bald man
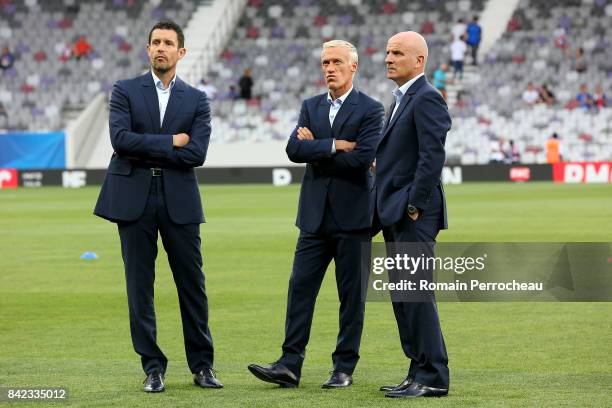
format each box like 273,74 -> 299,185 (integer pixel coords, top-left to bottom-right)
383,189 -> 449,388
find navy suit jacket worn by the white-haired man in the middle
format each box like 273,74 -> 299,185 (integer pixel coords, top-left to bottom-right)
286,88 -> 384,233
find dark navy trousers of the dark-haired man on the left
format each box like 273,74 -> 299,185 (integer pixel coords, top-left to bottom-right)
118,177 -> 213,373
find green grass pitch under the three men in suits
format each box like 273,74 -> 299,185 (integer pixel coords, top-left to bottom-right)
0,181 -> 612,408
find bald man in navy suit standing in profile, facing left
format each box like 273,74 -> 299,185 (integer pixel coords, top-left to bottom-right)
374,32 -> 451,397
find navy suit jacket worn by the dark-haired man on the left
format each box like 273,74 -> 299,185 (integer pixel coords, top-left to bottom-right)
94,72 -> 211,224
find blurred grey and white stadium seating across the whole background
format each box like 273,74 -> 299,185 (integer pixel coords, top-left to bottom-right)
0,0 -> 612,164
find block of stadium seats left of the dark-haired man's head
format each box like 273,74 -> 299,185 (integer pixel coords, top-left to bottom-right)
0,0 -> 195,131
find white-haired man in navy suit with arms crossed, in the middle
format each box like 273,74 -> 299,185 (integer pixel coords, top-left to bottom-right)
249,40 -> 384,388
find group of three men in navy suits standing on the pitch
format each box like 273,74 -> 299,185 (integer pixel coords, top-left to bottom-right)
94,21 -> 451,397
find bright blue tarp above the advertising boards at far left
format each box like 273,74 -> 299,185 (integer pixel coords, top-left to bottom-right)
0,132 -> 66,169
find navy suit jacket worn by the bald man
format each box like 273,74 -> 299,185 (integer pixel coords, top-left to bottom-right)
376,76 -> 451,229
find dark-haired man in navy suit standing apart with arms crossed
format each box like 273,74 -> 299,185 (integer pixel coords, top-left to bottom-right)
94,21 -> 223,392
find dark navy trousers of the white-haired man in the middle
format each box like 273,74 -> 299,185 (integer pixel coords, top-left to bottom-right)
279,203 -> 371,377
